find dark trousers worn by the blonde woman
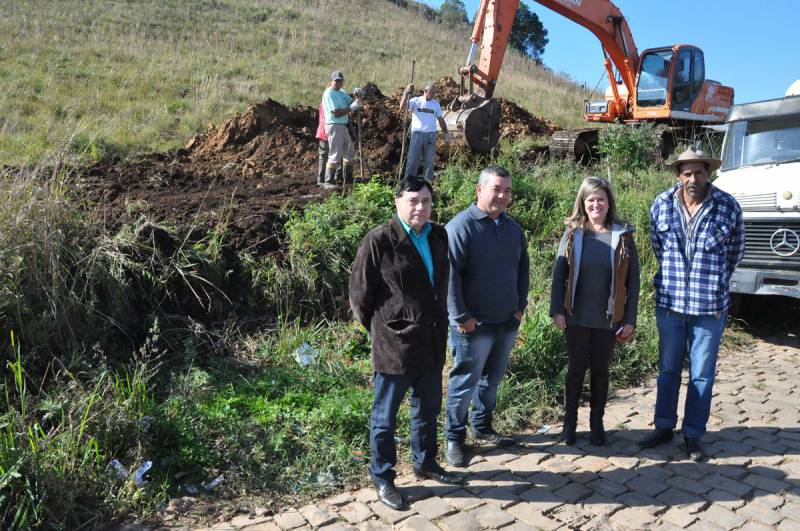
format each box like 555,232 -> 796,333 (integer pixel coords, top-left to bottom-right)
564,326 -> 616,423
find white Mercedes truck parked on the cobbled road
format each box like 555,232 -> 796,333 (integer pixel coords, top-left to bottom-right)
714,80 -> 800,299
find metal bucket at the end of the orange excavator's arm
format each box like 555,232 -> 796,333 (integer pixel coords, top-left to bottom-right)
444,95 -> 500,153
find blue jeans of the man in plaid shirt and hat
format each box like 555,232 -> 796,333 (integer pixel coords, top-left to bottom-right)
655,308 -> 727,438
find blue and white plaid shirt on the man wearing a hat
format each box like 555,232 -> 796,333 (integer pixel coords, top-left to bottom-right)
650,183 -> 744,315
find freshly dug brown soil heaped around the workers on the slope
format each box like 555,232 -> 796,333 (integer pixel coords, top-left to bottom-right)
81,78 -> 555,254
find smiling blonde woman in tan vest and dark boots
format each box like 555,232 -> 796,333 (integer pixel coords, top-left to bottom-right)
550,177 -> 639,446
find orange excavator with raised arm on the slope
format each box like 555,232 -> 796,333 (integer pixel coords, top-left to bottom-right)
445,0 -> 733,159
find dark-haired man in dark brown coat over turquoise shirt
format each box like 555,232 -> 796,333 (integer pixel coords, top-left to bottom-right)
350,178 -> 461,509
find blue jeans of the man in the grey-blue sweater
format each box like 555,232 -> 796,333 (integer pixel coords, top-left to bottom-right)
445,317 -> 519,442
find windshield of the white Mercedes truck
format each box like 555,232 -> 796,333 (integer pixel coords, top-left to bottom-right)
722,118 -> 800,170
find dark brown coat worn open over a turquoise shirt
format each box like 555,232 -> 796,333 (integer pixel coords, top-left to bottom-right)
350,216 -> 450,374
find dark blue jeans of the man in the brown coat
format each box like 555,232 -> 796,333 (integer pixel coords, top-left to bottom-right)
369,372 -> 442,481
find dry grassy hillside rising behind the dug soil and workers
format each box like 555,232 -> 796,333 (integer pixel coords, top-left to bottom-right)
0,0 -> 582,164
